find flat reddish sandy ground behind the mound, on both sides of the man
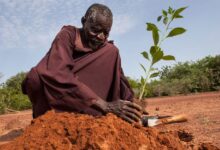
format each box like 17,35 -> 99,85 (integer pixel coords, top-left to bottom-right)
0,92 -> 220,147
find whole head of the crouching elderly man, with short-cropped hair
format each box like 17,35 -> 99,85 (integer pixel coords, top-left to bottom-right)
81,4 -> 113,50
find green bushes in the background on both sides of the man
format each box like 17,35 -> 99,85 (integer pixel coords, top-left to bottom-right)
0,55 -> 220,114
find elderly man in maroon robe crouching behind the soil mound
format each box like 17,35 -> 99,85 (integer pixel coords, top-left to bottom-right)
22,4 -> 142,123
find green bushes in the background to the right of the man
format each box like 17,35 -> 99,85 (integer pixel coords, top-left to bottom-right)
128,55 -> 220,98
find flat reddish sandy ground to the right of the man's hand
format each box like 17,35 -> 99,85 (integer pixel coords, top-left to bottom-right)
148,92 -> 220,148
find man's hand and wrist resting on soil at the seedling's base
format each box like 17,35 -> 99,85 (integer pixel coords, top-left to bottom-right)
94,99 -> 142,123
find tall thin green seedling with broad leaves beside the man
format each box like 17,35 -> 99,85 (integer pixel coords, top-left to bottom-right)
139,7 -> 187,100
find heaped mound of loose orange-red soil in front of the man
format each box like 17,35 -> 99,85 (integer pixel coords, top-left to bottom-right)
0,111 -> 218,150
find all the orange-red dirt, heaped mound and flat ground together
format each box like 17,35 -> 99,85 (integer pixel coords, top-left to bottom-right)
0,92 -> 220,150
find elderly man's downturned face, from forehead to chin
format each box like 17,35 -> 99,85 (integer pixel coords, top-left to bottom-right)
83,14 -> 112,50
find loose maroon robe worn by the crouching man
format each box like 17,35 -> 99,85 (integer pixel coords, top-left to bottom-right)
22,26 -> 133,118
